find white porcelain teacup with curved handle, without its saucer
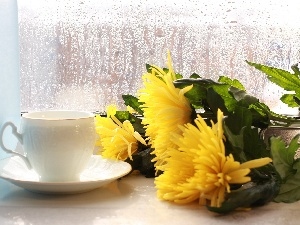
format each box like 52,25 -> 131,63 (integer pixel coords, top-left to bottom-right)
0,111 -> 96,182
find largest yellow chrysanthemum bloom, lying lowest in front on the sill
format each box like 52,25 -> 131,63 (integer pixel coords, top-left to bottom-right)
155,110 -> 272,207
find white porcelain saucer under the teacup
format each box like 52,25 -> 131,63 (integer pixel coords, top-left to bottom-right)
0,155 -> 131,194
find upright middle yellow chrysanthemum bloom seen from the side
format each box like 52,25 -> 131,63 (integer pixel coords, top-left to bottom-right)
139,53 -> 192,169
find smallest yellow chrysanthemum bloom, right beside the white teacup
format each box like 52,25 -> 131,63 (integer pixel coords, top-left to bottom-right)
95,105 -> 146,160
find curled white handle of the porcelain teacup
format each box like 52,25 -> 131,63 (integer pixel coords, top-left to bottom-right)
0,122 -> 32,169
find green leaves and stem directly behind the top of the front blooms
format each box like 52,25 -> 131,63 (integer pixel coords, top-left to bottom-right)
174,76 -> 293,128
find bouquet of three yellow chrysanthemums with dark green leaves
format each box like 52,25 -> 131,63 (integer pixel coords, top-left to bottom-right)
96,53 -> 300,213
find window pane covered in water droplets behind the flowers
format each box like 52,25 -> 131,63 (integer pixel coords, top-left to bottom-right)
18,0 -> 300,113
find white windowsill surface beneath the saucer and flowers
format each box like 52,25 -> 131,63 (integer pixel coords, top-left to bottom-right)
0,171 -> 300,225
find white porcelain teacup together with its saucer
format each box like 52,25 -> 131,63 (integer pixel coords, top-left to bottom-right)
0,110 -> 131,193
